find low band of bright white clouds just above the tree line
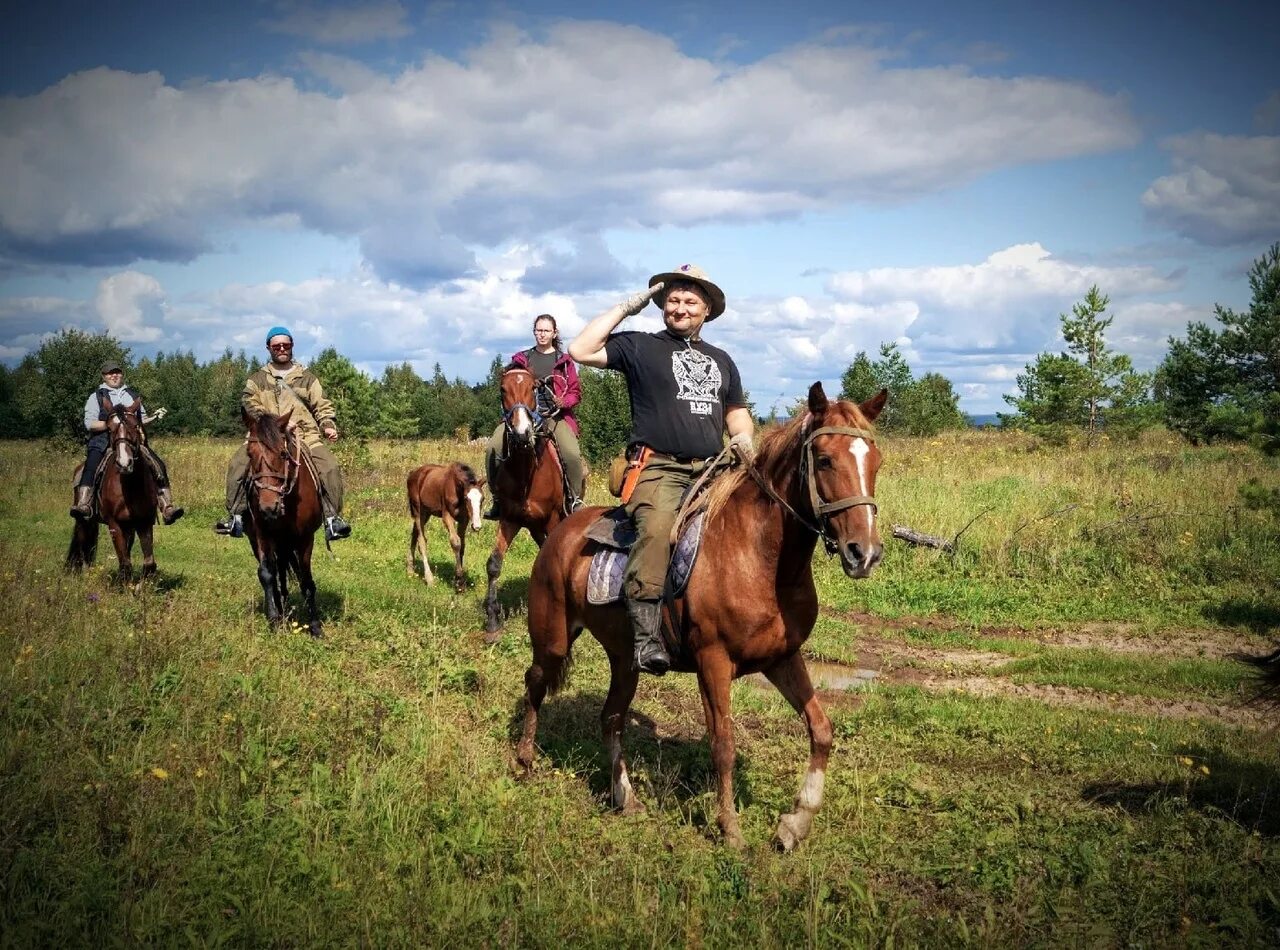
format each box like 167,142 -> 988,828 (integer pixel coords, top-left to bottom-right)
0,245 -> 1210,412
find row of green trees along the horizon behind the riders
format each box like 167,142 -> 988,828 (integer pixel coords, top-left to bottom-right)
0,243 -> 1280,463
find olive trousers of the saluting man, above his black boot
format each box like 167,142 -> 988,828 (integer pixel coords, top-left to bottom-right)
622,457 -> 707,600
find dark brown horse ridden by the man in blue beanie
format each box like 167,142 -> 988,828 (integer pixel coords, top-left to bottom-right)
244,410 -> 324,636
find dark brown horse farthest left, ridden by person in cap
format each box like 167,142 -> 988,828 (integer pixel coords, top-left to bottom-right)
67,399 -> 159,584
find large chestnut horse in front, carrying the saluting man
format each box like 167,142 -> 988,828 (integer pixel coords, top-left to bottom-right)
516,383 -> 888,850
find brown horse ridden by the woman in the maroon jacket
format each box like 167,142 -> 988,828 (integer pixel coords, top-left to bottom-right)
484,366 -> 564,643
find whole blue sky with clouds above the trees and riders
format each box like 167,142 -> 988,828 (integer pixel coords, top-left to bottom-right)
0,0 -> 1280,412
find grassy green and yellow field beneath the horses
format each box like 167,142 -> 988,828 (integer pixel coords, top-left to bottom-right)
0,433 -> 1280,946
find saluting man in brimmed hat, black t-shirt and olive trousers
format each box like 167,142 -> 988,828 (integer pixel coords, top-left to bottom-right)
568,264 -> 754,676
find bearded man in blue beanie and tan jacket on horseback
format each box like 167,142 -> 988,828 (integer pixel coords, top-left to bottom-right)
214,326 -> 351,542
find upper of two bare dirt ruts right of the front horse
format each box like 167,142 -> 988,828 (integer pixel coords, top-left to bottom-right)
822,608 -> 1272,658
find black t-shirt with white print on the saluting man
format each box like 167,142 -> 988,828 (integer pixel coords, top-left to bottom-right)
604,330 -> 746,458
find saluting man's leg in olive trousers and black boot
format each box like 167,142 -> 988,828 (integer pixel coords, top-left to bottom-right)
622,458 -> 692,676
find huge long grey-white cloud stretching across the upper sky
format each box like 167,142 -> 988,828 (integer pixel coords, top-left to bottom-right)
0,22 -> 1138,287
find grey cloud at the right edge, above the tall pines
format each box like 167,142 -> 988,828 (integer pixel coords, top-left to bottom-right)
1142,133 -> 1280,253
